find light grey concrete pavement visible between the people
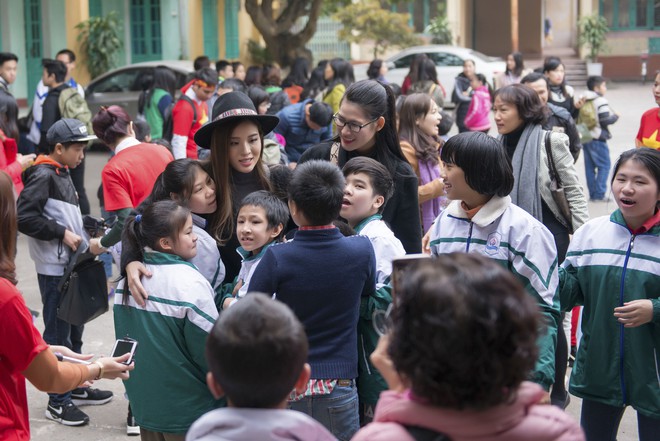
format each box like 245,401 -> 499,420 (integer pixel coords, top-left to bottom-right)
16,83 -> 655,441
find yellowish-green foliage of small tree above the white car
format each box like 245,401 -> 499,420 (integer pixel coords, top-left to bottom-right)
334,0 -> 419,58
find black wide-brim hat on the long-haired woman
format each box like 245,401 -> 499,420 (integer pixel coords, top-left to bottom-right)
195,92 -> 280,148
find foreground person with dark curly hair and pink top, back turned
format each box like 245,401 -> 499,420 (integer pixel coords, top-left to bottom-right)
353,253 -> 584,441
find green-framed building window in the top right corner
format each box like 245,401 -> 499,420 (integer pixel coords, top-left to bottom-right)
600,0 -> 660,31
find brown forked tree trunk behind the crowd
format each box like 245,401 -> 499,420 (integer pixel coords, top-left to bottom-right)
245,0 -> 323,66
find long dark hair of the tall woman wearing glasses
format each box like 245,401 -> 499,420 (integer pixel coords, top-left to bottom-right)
342,80 -> 408,178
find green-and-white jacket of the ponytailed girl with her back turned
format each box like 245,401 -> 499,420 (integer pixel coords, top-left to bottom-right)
114,251 -> 218,433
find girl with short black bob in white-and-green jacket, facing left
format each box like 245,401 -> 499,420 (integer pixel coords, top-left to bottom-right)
428,132 -> 559,390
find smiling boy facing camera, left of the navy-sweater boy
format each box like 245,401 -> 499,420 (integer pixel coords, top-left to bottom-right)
220,190 -> 289,309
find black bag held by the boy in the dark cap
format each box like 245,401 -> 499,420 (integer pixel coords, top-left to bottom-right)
57,245 -> 108,326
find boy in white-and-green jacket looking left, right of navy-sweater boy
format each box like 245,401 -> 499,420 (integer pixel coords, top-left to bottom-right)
340,156 -> 406,424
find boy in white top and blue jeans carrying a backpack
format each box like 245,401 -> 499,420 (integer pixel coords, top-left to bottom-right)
583,76 -> 619,201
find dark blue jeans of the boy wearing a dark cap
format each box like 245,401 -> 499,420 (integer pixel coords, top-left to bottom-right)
37,274 -> 84,405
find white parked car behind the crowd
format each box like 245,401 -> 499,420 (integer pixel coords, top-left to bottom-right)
354,45 -> 506,103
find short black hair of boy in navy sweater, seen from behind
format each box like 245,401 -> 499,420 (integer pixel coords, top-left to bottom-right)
289,160 -> 346,225
